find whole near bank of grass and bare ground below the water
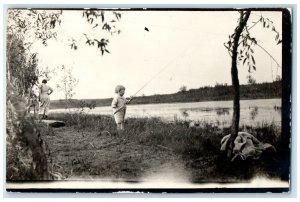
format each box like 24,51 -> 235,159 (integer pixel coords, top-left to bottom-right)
45,114 -> 281,182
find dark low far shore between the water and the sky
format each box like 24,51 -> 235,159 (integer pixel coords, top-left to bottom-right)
51,81 -> 282,109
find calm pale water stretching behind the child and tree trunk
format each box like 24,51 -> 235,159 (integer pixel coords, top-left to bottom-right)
50,99 -> 281,126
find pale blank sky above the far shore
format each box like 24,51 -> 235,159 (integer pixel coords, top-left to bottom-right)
29,10 -> 282,99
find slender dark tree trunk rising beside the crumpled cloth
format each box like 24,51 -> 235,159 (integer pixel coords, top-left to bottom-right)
227,11 -> 251,158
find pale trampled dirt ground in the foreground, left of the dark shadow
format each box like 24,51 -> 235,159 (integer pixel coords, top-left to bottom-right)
45,127 -> 191,182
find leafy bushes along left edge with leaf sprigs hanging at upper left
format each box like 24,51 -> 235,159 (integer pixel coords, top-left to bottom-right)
6,9 -> 121,181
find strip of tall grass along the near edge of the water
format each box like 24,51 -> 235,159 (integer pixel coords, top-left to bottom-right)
50,113 -> 281,161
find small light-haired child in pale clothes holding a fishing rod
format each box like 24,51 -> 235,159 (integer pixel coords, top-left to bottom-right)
111,85 -> 132,131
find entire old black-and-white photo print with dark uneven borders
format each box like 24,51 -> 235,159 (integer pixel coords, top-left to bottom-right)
4,8 -> 292,193
